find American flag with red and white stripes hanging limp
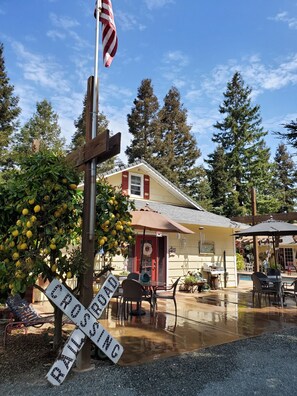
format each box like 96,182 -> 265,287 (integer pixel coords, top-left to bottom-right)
95,0 -> 118,67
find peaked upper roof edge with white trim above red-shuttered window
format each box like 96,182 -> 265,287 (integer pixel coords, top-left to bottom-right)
103,160 -> 205,212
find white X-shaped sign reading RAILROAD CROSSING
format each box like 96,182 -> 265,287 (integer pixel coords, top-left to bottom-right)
45,274 -> 123,385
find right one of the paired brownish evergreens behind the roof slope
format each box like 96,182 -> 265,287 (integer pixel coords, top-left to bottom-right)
156,87 -> 201,196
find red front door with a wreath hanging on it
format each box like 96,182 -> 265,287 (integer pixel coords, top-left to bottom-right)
135,235 -> 158,281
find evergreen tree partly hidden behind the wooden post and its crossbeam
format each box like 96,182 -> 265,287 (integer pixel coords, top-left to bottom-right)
70,95 -> 115,173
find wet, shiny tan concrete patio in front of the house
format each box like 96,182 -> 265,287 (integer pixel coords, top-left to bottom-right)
88,282 -> 297,365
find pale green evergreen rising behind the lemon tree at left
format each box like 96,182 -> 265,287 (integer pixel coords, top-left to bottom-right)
13,99 -> 65,163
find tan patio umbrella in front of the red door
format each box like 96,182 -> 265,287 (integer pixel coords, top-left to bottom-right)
131,205 -> 194,272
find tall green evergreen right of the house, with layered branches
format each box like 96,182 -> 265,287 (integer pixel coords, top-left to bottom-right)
212,72 -> 271,216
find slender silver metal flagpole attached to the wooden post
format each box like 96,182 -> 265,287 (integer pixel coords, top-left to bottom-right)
89,0 -> 102,240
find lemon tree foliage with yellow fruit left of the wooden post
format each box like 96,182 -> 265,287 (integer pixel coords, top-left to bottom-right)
0,152 -> 82,294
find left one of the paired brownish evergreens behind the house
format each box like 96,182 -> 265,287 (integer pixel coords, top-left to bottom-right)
125,79 -> 160,167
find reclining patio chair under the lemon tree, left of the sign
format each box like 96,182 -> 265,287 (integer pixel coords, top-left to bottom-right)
3,294 -> 54,347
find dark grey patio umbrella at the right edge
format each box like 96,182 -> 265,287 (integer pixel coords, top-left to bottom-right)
234,217 -> 297,266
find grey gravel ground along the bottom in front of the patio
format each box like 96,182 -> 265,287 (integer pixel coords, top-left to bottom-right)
0,328 -> 297,396
